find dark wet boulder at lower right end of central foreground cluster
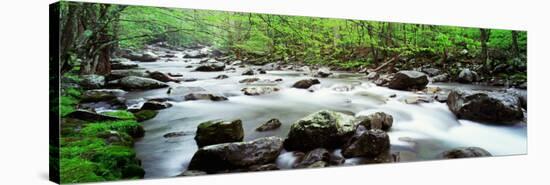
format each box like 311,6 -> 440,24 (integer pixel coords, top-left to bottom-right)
342,128 -> 390,158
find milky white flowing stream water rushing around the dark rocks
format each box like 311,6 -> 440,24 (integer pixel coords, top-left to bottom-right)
126,50 -> 527,178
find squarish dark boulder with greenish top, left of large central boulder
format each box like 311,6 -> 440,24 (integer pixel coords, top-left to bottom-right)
195,119 -> 244,148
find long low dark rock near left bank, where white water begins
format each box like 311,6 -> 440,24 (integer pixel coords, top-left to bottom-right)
115,76 -> 168,90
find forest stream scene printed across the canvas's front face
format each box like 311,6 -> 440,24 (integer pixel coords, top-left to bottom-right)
52,1 -> 527,183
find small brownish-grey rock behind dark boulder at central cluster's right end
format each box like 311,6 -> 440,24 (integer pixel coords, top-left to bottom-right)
354,112 -> 393,131
